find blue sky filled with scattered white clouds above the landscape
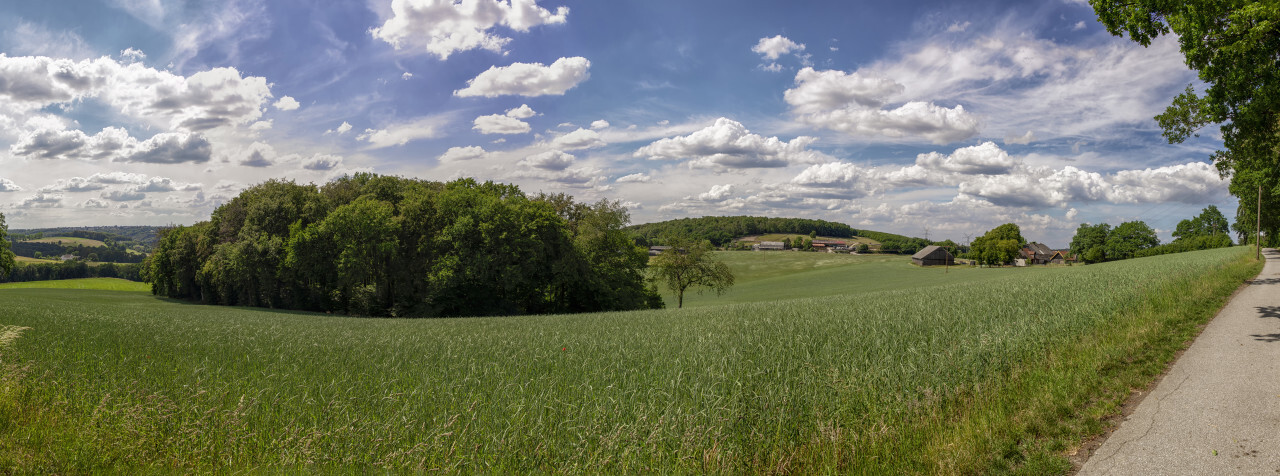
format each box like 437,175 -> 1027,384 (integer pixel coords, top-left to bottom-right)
0,0 -> 1236,247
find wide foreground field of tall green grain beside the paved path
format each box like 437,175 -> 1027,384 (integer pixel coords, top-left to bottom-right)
0,248 -> 1261,473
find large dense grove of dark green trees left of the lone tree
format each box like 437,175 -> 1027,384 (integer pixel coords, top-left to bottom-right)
146,174 -> 662,316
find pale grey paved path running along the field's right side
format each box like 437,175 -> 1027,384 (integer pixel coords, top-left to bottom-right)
1079,250 -> 1280,476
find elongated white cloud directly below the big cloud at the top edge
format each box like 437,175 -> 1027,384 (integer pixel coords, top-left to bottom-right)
453,56 -> 591,97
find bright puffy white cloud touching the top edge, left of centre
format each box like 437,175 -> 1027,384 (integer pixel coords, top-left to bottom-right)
370,0 -> 568,60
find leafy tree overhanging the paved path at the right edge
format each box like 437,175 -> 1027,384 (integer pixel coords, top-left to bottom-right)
1091,0 -> 1280,245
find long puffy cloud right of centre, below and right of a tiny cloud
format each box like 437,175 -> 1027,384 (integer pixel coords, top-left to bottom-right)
783,68 -> 978,143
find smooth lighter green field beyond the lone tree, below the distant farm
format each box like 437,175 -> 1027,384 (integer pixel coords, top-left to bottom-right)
659,251 -> 1018,307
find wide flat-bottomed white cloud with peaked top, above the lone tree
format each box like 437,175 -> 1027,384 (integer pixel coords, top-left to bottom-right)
635,118 -> 824,169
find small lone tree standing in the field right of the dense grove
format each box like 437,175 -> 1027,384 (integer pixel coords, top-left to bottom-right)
649,237 -> 733,308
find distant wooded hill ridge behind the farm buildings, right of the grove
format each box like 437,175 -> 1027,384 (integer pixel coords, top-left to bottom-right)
627,216 -> 856,247
